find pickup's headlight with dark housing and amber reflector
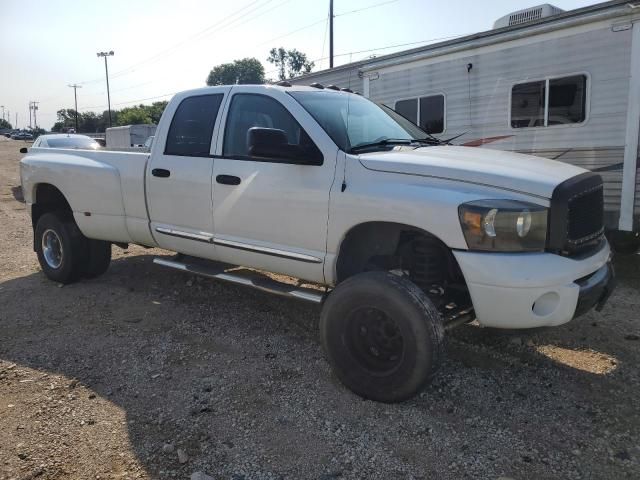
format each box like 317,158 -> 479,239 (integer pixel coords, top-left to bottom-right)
458,200 -> 547,252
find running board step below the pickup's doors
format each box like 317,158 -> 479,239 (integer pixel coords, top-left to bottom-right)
153,255 -> 325,304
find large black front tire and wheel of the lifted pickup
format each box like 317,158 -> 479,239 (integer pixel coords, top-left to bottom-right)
320,271 -> 444,403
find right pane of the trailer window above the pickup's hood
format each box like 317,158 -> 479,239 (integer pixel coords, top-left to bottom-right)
547,75 -> 587,125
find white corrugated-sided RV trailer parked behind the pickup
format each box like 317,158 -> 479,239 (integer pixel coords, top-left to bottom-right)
290,0 -> 640,241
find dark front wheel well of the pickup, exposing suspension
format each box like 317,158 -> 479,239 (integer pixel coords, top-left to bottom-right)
336,222 -> 471,316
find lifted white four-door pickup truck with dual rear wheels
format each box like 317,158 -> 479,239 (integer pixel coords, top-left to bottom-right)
21,85 -> 613,402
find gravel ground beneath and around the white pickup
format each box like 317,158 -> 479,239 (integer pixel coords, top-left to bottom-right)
0,138 -> 640,480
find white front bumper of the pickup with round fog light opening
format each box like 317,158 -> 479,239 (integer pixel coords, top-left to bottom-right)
454,242 -> 614,328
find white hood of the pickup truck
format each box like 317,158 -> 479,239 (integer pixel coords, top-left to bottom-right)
359,146 -> 586,198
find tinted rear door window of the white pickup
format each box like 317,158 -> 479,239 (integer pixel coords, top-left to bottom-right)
164,93 -> 223,157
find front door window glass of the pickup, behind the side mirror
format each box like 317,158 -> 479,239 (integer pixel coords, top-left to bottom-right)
222,93 -> 320,160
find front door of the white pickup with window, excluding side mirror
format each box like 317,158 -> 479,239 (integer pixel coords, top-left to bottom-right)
213,86 -> 338,281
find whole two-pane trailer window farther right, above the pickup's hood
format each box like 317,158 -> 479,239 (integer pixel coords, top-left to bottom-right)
511,75 -> 587,128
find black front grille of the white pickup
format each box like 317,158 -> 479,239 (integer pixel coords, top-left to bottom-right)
547,173 -> 604,256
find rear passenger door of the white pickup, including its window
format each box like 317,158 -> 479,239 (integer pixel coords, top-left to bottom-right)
146,87 -> 229,258
